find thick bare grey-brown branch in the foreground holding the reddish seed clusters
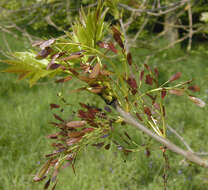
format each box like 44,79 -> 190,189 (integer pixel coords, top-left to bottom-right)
114,104 -> 208,168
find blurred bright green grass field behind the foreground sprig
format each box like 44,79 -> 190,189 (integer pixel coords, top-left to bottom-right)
0,31 -> 208,190
